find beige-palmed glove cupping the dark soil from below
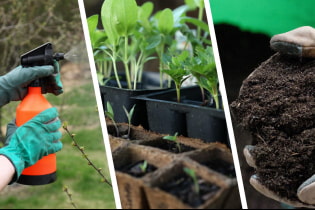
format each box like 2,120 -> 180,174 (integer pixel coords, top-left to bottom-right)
243,145 -> 315,208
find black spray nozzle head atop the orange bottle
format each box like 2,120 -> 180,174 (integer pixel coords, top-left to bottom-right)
21,42 -> 64,67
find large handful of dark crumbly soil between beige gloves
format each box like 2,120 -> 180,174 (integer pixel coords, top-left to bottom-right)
231,53 -> 315,200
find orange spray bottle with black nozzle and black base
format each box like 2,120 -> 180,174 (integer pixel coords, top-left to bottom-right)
16,43 -> 64,185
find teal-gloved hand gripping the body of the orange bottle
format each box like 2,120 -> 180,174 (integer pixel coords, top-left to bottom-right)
0,108 -> 62,182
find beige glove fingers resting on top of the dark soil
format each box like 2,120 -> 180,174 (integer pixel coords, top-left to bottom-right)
270,26 -> 315,58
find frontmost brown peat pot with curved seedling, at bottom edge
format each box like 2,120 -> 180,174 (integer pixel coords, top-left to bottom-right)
144,159 -> 230,209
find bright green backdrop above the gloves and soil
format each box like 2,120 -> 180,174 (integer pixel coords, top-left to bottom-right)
209,0 -> 315,36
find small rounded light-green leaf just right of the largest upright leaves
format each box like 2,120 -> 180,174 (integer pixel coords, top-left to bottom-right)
156,8 -> 174,34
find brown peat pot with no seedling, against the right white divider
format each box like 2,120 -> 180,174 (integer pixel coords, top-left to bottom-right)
183,143 -> 242,209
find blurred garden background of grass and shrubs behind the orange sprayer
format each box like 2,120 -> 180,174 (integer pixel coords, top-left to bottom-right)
0,0 -> 115,209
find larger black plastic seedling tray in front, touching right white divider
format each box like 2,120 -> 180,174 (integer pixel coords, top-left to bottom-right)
137,86 -> 229,143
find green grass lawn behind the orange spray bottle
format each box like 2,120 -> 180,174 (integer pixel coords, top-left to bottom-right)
0,75 -> 115,209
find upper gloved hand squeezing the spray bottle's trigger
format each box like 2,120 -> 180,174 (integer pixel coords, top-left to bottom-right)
0,61 -> 62,106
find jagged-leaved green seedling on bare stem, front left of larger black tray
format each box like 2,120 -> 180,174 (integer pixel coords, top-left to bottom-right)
163,51 -> 189,103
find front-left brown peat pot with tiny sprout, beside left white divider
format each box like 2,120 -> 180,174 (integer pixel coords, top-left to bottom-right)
113,144 -> 174,209
